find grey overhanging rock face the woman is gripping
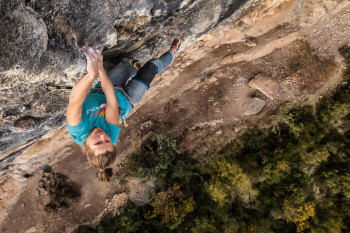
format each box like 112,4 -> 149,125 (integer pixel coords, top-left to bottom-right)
0,0 -> 252,157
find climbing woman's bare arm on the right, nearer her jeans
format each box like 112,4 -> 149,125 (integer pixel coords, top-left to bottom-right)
96,51 -> 119,126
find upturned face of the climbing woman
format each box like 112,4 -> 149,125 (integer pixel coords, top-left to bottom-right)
86,128 -> 114,156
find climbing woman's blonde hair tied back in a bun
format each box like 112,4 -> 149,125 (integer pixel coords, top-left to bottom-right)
85,145 -> 117,185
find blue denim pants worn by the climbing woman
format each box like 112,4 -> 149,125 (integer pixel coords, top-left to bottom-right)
108,50 -> 174,106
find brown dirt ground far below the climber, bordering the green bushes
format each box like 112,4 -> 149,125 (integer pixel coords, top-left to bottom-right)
0,1 -> 350,233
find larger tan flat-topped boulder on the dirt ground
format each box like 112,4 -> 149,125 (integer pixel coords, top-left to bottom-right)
249,74 -> 280,100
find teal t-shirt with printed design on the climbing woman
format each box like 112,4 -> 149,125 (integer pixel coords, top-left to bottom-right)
66,89 -> 131,146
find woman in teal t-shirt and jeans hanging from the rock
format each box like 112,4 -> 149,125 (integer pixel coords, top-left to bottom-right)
66,38 -> 181,182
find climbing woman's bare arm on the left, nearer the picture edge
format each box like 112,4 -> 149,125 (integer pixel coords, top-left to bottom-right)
67,48 -> 98,126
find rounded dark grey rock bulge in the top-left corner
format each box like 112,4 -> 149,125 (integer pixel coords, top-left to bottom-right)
0,1 -> 48,70
